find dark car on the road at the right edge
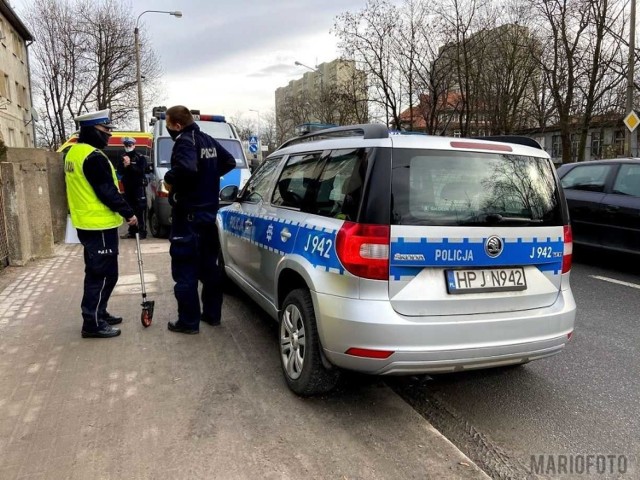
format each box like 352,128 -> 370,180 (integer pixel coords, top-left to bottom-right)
558,158 -> 640,254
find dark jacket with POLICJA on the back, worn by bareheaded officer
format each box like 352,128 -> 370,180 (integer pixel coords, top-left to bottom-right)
164,123 -> 236,214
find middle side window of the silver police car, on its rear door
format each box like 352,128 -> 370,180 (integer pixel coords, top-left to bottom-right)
271,153 -> 321,210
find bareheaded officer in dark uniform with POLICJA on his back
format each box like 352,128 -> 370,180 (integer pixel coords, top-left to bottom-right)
164,105 -> 236,334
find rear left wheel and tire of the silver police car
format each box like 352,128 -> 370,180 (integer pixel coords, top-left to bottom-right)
279,288 -> 340,397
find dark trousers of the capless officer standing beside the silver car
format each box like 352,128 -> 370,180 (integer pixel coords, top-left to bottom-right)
169,213 -> 222,330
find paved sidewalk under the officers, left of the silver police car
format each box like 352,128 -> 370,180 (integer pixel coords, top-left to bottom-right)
0,239 -> 488,480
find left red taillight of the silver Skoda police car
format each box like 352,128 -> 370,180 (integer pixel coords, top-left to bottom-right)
336,222 -> 390,280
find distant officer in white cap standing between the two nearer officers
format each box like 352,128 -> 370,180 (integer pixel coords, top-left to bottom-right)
118,137 -> 147,238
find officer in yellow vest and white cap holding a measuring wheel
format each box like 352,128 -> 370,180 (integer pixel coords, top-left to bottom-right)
64,109 -> 138,338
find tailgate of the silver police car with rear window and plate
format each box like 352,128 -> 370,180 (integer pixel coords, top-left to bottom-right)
389,149 -> 566,316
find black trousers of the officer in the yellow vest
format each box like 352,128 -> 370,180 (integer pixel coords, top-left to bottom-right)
78,228 -> 118,332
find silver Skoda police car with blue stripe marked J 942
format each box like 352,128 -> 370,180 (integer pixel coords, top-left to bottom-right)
218,124 -> 576,395
